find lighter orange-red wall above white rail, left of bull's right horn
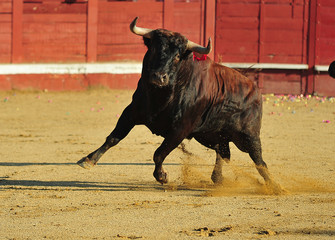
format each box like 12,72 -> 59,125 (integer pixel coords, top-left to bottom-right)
0,0 -> 205,63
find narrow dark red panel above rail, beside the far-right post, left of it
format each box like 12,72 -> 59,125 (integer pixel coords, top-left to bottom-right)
259,1 -> 307,64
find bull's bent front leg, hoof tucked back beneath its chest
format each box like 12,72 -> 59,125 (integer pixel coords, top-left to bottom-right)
154,135 -> 184,184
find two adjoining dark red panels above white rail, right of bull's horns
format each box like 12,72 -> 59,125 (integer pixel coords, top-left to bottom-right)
216,0 -> 308,63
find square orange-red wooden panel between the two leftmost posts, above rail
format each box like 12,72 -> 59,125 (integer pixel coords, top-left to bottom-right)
22,0 -> 87,63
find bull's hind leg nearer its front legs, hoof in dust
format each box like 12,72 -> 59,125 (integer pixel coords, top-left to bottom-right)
211,141 -> 230,184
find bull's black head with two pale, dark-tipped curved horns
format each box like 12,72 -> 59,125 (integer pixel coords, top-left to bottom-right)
130,17 -> 212,87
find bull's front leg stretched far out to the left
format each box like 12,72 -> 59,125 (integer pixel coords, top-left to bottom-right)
77,105 -> 135,169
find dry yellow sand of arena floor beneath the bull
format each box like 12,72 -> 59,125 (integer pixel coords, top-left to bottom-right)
0,89 -> 335,239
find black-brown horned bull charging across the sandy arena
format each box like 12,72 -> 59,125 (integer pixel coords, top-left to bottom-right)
78,18 -> 282,191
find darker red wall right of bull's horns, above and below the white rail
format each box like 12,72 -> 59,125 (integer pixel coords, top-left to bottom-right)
215,0 -> 335,95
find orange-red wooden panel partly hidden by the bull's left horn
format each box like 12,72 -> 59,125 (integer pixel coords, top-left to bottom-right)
97,0 -> 163,62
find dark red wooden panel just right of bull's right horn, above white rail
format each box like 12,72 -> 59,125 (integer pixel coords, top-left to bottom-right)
215,0 -> 259,62
